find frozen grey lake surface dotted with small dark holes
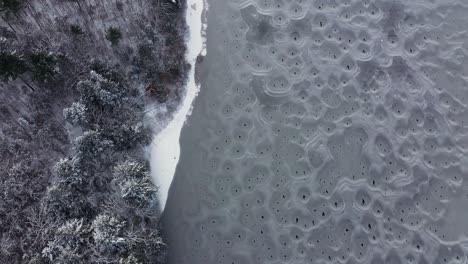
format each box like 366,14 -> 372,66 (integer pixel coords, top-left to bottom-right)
162,0 -> 468,264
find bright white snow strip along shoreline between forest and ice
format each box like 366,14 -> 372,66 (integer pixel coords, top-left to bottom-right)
151,0 -> 206,210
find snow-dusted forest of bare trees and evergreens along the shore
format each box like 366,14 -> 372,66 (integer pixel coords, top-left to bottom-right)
0,0 -> 189,264
